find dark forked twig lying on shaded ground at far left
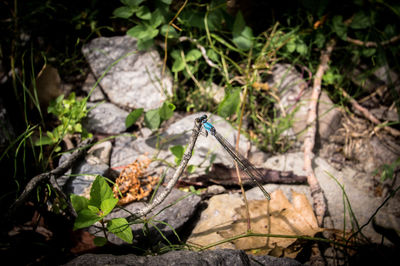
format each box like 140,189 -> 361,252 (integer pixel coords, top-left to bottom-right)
10,138 -> 93,216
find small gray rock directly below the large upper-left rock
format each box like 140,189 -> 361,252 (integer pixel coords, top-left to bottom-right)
82,103 -> 128,134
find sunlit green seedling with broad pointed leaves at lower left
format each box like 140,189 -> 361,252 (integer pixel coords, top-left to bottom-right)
71,176 -> 133,246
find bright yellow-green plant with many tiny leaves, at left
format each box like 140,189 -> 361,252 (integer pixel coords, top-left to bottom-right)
35,93 -> 91,151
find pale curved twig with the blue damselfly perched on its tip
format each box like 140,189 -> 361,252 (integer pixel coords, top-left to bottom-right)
127,119 -> 201,221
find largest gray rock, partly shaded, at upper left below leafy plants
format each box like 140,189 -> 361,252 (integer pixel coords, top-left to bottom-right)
82,36 -> 172,111
